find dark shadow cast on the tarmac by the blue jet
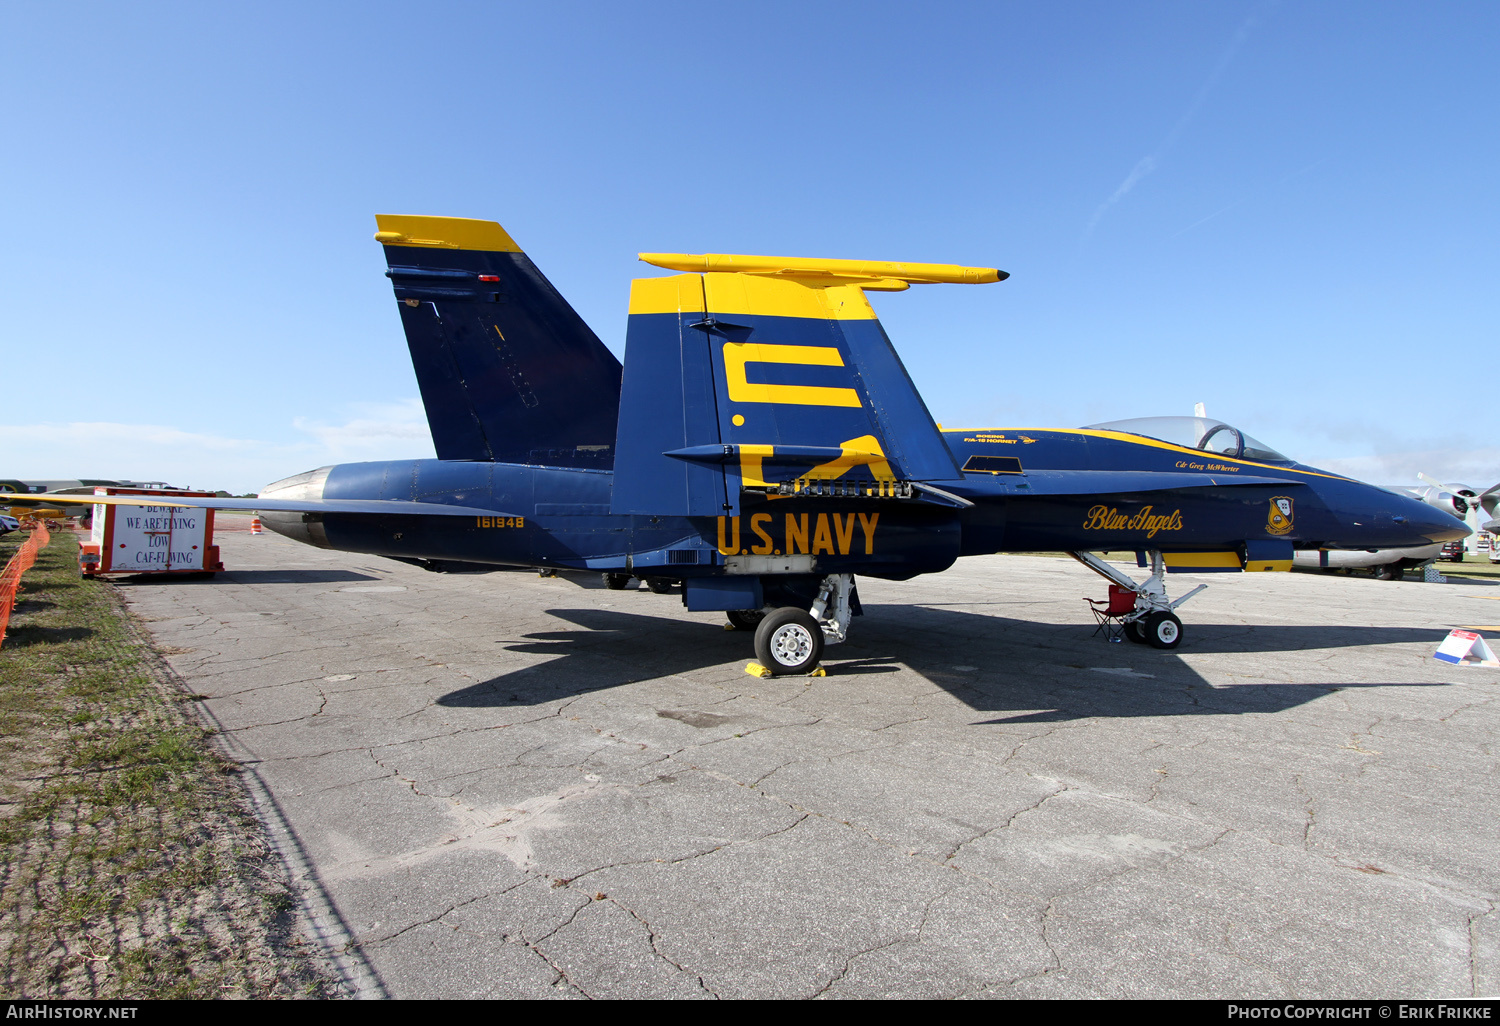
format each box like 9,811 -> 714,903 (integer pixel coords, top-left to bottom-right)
438,605 -> 1445,725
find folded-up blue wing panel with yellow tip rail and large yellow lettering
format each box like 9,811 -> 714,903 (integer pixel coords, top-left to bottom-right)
612,255 -> 1005,516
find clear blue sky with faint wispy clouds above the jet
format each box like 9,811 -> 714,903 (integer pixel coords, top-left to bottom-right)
0,0 -> 1500,492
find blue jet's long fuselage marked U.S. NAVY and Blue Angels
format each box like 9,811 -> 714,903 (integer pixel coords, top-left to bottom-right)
261,429 -> 1469,579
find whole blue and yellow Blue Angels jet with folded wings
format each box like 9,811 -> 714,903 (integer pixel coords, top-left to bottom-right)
11,215 -> 1469,675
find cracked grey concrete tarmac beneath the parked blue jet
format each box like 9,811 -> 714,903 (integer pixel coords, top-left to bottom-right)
122,531 -> 1500,998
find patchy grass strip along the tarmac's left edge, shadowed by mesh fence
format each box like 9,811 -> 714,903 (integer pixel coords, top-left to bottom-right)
0,531 -> 333,999
